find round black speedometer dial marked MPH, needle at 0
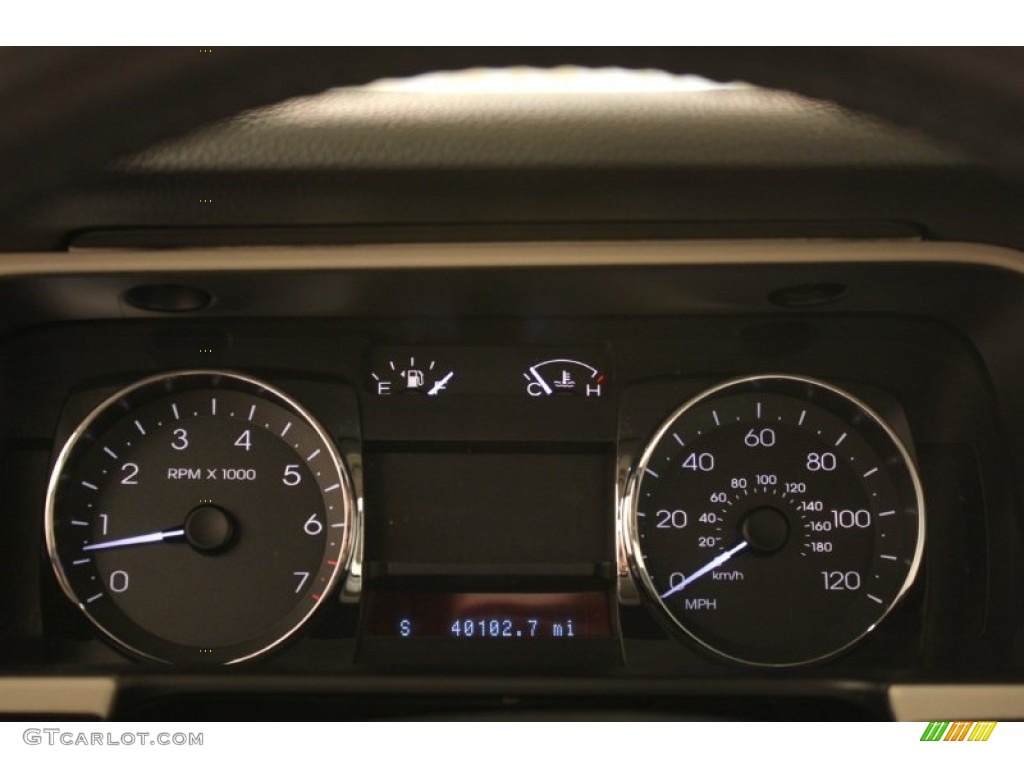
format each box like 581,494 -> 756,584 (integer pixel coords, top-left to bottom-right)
627,376 -> 924,666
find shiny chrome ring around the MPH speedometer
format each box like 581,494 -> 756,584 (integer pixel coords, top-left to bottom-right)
620,374 -> 926,669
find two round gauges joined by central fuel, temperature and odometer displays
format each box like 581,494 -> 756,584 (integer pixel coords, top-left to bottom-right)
34,333 -> 926,667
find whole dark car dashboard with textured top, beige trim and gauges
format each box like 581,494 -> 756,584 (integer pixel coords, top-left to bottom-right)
0,51 -> 1024,721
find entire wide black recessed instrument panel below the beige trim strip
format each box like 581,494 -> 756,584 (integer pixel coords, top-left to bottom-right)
0,243 -> 1016,696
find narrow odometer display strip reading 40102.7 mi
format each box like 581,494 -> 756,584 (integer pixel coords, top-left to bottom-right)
367,591 -> 611,643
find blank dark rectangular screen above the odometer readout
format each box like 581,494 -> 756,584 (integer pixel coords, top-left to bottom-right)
364,447 -> 614,572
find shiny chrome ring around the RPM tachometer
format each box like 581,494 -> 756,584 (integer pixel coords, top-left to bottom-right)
44,369 -> 361,666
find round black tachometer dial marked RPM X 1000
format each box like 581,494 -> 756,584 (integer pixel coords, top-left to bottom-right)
46,372 -> 352,664
